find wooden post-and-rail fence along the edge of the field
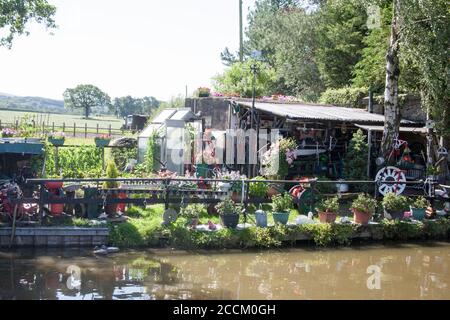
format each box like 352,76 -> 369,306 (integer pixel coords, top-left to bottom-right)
0,119 -> 135,138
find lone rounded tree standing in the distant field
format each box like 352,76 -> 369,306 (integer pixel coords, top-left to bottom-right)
64,84 -> 111,119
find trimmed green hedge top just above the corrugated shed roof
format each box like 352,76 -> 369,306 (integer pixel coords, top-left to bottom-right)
320,87 -> 369,108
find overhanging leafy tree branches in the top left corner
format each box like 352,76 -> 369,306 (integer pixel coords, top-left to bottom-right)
0,0 -> 56,49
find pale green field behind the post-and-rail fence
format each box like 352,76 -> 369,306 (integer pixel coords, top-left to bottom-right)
0,109 -> 123,129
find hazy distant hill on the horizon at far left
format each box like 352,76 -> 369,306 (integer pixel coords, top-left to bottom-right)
0,92 -> 66,113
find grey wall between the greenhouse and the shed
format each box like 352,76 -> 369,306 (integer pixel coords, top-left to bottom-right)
185,97 -> 229,130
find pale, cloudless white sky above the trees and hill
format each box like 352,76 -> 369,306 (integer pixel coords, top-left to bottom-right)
0,0 -> 254,100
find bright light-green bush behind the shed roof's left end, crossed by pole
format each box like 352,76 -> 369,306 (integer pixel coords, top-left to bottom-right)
214,60 -> 275,98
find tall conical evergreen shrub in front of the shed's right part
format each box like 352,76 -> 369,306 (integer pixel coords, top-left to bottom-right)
344,129 -> 369,189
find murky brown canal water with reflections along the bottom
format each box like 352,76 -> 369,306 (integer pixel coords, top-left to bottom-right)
0,243 -> 450,300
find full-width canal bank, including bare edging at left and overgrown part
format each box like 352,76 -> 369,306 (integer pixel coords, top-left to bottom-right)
0,218 -> 450,250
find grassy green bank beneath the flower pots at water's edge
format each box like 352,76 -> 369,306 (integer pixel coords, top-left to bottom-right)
109,206 -> 450,250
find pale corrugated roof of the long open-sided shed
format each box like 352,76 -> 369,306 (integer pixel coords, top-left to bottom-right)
235,100 -> 414,123
